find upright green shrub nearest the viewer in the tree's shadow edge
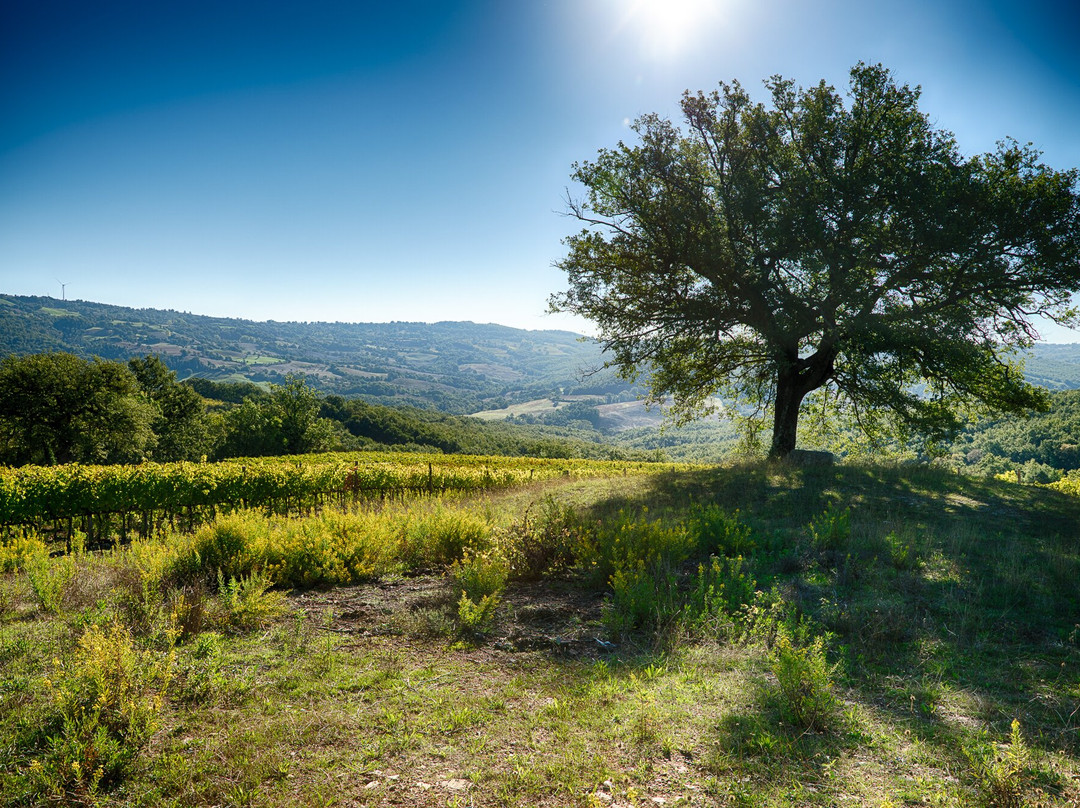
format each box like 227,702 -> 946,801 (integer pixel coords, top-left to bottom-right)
771,634 -> 839,732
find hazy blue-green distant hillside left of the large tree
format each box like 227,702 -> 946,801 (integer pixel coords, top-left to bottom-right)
0,295 -> 626,414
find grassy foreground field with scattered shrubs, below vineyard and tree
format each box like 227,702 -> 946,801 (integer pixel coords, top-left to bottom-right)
0,460 -> 1080,807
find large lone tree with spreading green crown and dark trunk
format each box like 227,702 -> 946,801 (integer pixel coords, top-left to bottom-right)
552,63 -> 1080,457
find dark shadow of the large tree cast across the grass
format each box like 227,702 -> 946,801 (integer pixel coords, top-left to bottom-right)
557,464 -> 1080,793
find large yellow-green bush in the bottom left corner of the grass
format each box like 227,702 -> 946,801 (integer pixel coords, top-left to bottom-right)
27,624 -> 174,804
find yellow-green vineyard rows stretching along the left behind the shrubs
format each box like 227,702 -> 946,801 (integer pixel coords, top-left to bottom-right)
0,453 -> 673,543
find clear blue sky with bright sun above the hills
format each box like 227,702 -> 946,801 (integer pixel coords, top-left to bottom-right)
0,0 -> 1080,341
